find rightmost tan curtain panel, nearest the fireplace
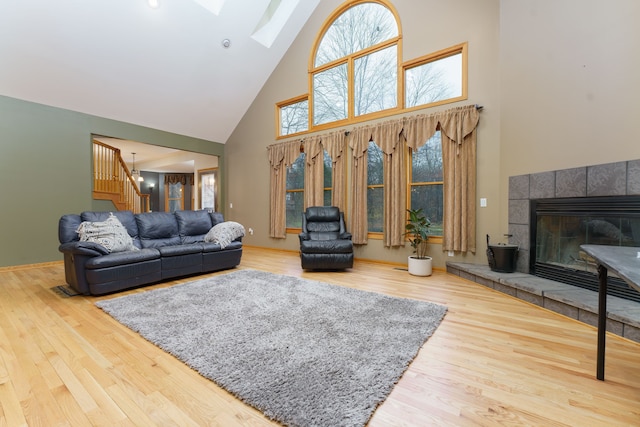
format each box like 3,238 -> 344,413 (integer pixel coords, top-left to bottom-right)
440,105 -> 480,253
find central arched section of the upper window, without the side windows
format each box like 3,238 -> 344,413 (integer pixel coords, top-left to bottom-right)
310,1 -> 400,127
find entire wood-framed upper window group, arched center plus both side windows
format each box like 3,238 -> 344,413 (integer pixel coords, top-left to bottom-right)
276,0 -> 467,138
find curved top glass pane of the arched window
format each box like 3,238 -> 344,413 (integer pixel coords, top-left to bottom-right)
315,3 -> 398,67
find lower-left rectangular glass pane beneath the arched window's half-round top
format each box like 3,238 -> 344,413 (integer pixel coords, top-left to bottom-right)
313,64 -> 349,125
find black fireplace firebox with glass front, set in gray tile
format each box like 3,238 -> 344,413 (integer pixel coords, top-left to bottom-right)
529,196 -> 640,302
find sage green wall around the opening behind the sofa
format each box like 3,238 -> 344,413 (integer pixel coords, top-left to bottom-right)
0,96 -> 225,267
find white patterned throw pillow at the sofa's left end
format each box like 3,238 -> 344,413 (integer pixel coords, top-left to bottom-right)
76,213 -> 138,252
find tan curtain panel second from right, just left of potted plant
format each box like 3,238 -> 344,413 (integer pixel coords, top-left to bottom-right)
373,119 -> 407,247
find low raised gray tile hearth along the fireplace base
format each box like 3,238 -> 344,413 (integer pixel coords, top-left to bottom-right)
447,262 -> 640,342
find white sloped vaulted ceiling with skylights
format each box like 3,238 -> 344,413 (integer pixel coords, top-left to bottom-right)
0,0 -> 320,143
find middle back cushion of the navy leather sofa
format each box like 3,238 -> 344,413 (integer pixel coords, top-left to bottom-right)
135,212 -> 181,248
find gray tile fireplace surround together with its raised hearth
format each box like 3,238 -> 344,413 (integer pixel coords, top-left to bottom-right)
447,160 -> 640,342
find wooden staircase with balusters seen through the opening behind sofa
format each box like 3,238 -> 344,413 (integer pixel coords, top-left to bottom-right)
93,140 -> 149,213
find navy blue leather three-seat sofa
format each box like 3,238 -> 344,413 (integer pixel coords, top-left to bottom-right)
58,210 -> 242,295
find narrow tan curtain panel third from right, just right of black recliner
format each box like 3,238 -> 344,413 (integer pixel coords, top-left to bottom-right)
349,126 -> 371,245
